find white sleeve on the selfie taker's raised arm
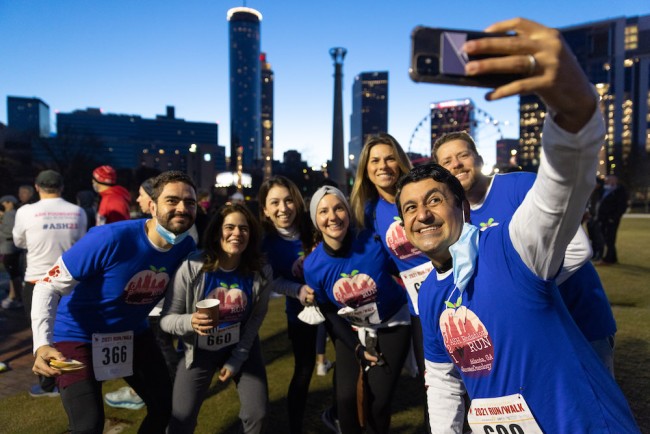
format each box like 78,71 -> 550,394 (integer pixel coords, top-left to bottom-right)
508,103 -> 605,279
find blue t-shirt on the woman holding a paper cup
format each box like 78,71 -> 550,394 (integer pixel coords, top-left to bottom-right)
203,270 -> 253,327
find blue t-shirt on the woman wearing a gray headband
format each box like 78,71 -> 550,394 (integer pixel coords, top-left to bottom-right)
304,230 -> 406,325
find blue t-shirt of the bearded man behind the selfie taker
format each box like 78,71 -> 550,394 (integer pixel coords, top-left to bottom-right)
470,172 -> 616,341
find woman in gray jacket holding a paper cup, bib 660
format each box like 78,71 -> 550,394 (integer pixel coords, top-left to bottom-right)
160,204 -> 271,433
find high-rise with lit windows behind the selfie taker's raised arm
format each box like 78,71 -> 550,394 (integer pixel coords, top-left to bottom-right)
519,15 -> 650,175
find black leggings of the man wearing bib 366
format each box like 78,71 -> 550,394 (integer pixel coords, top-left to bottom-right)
60,331 -> 172,434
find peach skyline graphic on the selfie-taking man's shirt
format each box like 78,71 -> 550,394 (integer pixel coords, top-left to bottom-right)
440,304 -> 494,377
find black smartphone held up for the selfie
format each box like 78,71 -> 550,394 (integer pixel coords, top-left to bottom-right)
409,26 -> 523,88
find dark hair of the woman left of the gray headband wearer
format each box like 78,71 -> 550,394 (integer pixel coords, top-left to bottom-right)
257,175 -> 314,255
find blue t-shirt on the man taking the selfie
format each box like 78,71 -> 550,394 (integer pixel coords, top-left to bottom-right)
419,221 -> 638,433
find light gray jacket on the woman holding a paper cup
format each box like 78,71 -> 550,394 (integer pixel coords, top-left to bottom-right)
160,251 -> 273,375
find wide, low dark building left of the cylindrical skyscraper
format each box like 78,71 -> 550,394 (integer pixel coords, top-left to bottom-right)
43,106 -> 223,177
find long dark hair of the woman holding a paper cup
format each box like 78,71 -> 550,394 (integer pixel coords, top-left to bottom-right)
203,203 -> 264,274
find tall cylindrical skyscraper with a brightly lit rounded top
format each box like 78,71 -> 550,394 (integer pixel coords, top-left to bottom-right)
227,7 -> 262,170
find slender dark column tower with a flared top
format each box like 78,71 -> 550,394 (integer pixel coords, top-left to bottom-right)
327,47 -> 348,193
